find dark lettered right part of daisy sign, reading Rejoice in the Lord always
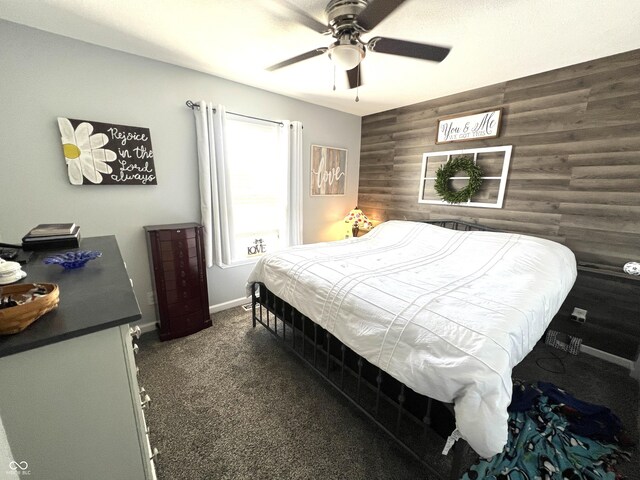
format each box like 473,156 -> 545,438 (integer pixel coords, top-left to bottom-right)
107,125 -> 156,185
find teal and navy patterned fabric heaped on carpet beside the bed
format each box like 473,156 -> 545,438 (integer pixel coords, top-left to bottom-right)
461,382 -> 628,480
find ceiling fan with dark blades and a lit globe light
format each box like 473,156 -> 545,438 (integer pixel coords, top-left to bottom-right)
267,0 -> 450,88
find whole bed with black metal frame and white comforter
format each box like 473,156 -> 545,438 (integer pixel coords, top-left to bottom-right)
247,221 -> 576,478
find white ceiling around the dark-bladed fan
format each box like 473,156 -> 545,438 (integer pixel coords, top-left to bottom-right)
0,0 -> 640,115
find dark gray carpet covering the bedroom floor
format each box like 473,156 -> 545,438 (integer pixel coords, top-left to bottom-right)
138,307 -> 640,480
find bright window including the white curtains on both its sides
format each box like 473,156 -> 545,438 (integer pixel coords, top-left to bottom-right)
194,101 -> 303,268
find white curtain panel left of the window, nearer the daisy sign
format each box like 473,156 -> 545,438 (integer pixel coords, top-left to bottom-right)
193,100 -> 233,267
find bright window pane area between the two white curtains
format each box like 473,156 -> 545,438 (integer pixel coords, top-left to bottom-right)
225,115 -> 288,263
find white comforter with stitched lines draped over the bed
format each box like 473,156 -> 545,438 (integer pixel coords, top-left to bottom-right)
247,221 -> 576,457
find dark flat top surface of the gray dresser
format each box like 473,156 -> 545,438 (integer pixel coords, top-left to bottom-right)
0,235 -> 142,357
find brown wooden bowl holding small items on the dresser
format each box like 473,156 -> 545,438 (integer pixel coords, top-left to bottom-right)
0,283 -> 60,335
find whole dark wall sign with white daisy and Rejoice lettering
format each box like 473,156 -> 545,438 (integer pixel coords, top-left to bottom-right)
58,118 -> 157,185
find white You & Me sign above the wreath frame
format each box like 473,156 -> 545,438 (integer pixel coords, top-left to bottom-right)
436,109 -> 502,143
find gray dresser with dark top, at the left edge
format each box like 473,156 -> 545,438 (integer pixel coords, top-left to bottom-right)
0,236 -> 157,480
